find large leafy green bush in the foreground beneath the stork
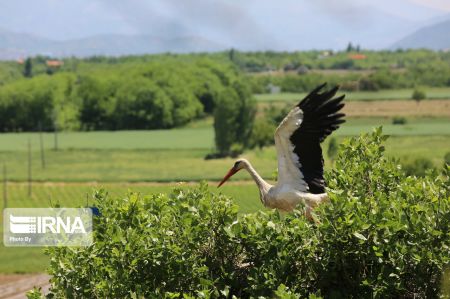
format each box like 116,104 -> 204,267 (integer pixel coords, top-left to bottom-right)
40,130 -> 450,298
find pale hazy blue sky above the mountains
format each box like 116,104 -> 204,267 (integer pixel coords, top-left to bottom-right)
0,0 -> 450,48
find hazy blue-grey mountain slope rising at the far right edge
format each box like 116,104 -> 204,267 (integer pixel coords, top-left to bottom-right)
391,19 -> 450,50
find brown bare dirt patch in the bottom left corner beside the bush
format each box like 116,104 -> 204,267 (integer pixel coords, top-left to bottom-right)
0,273 -> 50,299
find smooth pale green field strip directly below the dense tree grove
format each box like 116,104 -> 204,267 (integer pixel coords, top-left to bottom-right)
0,117 -> 450,152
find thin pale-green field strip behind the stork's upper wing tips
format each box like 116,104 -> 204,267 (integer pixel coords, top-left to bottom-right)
256,87 -> 450,102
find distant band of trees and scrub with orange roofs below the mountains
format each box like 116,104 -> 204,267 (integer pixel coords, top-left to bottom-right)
0,49 -> 450,91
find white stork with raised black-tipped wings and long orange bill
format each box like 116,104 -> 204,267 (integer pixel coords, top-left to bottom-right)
218,83 -> 345,219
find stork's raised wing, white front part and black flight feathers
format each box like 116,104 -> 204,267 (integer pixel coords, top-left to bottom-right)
275,83 -> 345,194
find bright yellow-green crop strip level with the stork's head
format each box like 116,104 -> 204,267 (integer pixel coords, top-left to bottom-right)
0,136 -> 450,182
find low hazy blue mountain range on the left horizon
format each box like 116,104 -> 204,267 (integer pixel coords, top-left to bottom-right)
0,30 -> 226,60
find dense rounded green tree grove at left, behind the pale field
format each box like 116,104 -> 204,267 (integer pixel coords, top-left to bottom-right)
0,59 -> 248,131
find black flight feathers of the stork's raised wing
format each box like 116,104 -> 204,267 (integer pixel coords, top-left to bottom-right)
290,83 -> 345,194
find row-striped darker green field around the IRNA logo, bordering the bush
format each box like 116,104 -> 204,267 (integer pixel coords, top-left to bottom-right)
0,184 -> 264,273
